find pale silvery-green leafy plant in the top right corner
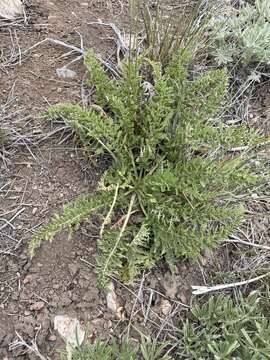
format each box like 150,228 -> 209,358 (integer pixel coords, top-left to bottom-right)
213,0 -> 270,68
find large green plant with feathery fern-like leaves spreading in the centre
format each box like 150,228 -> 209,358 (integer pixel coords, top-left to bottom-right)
30,51 -> 261,284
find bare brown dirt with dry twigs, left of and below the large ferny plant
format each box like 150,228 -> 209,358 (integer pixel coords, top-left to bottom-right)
0,0 -> 201,360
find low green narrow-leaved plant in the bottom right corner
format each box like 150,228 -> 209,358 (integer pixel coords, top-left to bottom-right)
179,292 -> 270,360
